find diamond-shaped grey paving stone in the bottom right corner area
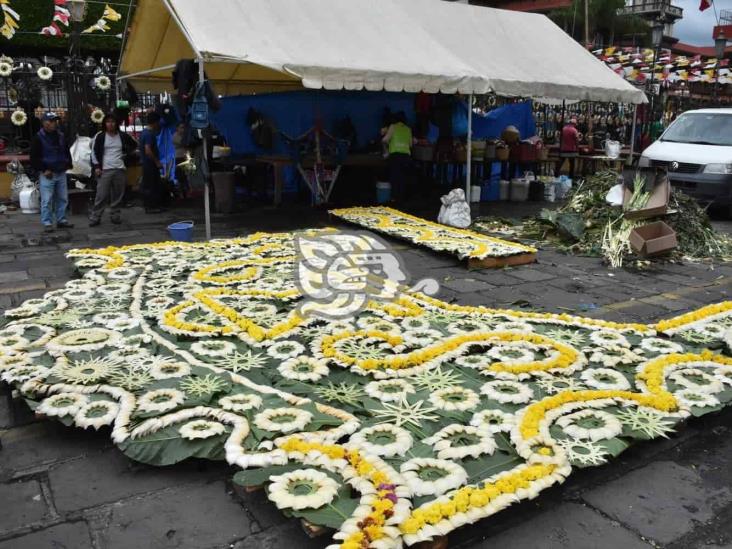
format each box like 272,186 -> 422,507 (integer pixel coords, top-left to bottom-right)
583,461 -> 732,544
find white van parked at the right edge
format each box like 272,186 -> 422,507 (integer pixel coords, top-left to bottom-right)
639,109 -> 732,213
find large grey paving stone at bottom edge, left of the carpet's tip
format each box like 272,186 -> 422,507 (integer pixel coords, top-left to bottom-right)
103,482 -> 252,549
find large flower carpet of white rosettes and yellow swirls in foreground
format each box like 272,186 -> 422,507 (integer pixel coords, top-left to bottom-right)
0,231 -> 732,549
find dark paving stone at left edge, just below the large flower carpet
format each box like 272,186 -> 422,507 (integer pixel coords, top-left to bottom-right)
0,421 -> 111,478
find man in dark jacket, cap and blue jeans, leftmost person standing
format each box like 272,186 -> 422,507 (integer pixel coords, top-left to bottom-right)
30,112 -> 73,233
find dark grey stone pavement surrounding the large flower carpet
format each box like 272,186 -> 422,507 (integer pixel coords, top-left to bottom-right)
0,201 -> 732,549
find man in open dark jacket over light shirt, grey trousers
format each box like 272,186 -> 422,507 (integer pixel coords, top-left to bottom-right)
89,114 -> 137,227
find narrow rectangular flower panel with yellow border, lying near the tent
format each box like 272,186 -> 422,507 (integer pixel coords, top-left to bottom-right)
330,206 -> 536,260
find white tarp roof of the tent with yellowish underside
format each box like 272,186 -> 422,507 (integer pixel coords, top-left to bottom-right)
121,0 -> 646,103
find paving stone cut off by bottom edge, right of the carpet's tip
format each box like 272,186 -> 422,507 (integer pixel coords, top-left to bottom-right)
473,503 -> 651,549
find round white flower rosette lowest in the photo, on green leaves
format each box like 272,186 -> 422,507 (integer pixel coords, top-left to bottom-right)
267,469 -> 339,510
